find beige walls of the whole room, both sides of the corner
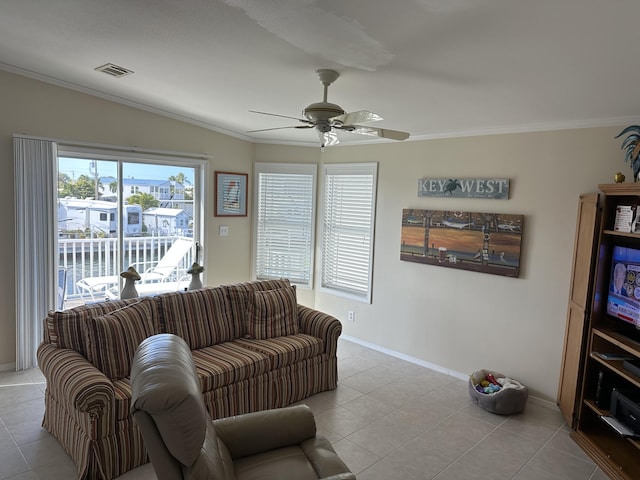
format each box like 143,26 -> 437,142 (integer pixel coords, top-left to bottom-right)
0,72 -> 630,401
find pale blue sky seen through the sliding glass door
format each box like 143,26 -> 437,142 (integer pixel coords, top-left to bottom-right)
58,157 -> 194,182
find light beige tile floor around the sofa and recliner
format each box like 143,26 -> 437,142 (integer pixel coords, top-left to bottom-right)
0,340 -> 606,480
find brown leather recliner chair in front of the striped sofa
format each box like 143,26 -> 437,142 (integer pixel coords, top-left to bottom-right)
131,334 -> 355,480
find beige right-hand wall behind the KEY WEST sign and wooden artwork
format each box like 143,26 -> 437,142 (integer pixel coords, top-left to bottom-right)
316,128 -> 629,401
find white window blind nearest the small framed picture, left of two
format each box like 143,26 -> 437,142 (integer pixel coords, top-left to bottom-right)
254,163 -> 316,288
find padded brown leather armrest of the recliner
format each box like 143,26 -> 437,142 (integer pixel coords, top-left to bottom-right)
213,405 -> 316,459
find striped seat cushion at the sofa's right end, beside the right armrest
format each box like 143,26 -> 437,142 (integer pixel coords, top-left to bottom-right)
233,333 -> 324,370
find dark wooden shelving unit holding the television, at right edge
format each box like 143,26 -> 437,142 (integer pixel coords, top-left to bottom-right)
559,183 -> 640,480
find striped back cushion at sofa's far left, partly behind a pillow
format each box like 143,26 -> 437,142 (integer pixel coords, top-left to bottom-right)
45,298 -> 138,358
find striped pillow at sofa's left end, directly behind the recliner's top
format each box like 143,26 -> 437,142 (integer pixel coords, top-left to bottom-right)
87,297 -> 160,380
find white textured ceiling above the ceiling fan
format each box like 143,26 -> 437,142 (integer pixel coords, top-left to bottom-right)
0,0 -> 640,145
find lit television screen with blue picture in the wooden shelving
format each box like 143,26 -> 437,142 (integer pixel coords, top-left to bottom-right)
607,246 -> 640,328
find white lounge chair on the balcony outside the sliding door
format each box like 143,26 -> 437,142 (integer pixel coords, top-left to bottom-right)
76,238 -> 193,300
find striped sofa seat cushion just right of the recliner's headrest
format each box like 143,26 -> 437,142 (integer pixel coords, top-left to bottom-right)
191,342 -> 271,392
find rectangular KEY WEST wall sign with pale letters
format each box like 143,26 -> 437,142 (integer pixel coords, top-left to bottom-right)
418,178 -> 509,200
